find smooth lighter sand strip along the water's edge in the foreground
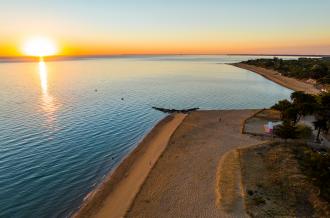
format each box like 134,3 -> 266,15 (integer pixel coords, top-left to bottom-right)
72,113 -> 187,218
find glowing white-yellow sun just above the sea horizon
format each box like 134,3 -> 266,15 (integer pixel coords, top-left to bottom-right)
23,37 -> 58,57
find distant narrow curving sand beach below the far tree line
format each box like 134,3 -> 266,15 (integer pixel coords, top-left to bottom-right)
231,63 -> 320,94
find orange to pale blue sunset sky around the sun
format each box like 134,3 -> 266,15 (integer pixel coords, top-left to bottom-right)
0,0 -> 330,56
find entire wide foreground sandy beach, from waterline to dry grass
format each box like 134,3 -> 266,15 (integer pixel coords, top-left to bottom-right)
74,110 -> 260,218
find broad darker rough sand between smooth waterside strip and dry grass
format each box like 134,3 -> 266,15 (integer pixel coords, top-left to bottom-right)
127,110 -> 259,217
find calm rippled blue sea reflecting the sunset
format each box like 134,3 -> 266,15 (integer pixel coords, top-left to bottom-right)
0,56 -> 291,218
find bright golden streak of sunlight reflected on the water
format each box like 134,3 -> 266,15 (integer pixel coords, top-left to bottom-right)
39,59 -> 58,127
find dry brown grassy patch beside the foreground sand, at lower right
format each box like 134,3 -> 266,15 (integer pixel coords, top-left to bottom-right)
239,143 -> 330,217
